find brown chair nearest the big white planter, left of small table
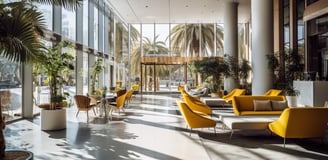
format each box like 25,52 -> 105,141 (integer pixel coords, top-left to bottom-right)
74,95 -> 96,122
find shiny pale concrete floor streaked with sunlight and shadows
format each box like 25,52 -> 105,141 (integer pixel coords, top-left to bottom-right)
5,94 -> 328,160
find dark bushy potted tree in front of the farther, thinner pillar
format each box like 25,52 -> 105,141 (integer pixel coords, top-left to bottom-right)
191,57 -> 230,95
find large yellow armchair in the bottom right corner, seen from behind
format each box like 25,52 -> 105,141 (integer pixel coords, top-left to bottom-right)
268,107 -> 328,146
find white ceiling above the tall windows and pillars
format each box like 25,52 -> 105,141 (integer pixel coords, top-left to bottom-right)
107,0 -> 251,24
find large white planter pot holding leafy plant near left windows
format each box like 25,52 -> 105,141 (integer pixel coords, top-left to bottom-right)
41,109 -> 66,130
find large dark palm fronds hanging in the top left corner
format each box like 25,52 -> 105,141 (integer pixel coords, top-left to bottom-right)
0,2 -> 44,63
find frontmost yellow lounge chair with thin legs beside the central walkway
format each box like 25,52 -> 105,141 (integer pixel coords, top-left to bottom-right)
177,100 -> 216,135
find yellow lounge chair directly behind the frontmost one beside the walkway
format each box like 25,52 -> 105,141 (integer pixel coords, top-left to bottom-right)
182,91 -> 212,114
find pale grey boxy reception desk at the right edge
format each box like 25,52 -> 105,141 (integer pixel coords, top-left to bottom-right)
293,81 -> 328,106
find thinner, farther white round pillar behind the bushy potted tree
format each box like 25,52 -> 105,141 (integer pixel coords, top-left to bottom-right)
223,2 -> 238,92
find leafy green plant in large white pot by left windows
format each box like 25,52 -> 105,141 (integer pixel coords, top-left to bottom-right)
34,41 -> 74,130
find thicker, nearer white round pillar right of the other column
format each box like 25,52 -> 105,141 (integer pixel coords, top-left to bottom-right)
251,0 -> 273,95
